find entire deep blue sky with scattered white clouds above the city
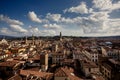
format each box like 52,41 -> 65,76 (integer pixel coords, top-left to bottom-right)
0,0 -> 120,37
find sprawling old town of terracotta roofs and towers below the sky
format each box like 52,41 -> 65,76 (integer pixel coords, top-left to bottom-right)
0,32 -> 120,80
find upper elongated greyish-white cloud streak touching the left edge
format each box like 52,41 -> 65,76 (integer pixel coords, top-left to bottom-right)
0,15 -> 23,25
